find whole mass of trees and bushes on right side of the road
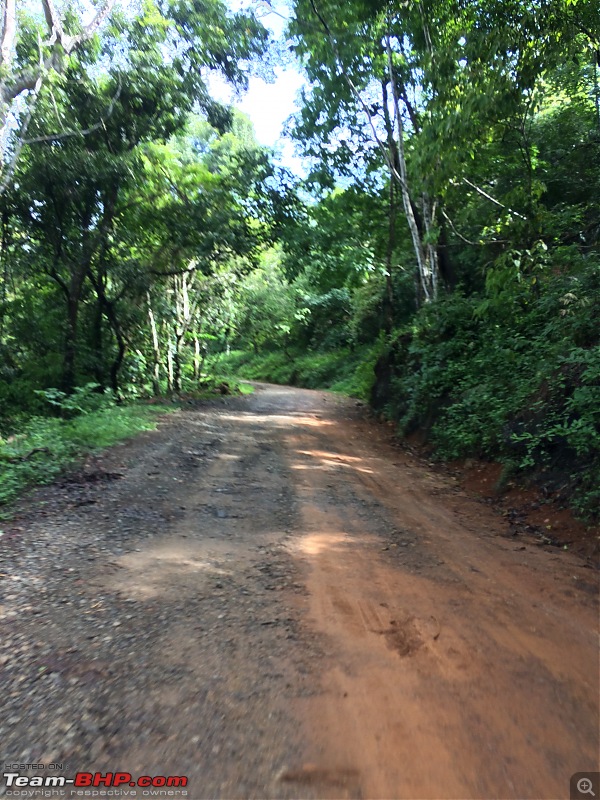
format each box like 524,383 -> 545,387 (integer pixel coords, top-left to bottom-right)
224,0 -> 600,515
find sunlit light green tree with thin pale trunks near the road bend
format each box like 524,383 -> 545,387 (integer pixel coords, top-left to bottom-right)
134,114 -> 288,392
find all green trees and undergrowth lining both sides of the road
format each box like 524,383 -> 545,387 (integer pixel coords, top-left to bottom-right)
0,0 -> 600,520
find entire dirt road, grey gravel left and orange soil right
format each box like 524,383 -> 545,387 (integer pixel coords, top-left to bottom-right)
0,385 -> 599,800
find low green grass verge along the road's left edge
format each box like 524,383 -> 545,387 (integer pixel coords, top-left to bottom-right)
0,404 -> 174,505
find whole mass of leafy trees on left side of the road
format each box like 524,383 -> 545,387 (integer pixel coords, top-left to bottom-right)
0,0 -> 277,417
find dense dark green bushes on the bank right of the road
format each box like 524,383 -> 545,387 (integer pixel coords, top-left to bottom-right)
379,279 -> 600,521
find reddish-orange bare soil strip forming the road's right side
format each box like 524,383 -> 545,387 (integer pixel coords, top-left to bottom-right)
252,387 -> 599,798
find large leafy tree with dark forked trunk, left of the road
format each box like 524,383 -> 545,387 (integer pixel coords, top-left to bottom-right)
0,2 -> 264,392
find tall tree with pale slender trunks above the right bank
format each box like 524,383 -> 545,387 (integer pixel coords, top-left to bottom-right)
290,0 -> 598,301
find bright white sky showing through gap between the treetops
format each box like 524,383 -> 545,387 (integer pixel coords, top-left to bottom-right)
211,0 -> 305,175
